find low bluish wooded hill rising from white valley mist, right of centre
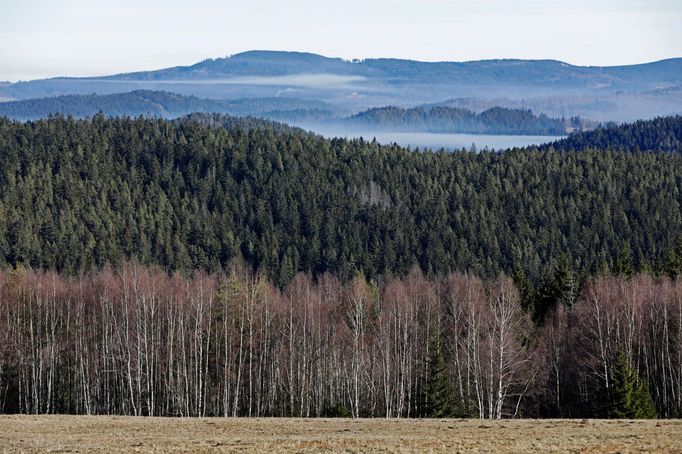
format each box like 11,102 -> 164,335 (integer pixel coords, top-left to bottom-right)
344,106 -> 567,135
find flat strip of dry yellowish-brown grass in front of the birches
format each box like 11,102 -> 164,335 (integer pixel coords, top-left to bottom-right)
0,416 -> 682,453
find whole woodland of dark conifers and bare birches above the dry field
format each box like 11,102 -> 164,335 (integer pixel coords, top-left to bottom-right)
0,115 -> 682,418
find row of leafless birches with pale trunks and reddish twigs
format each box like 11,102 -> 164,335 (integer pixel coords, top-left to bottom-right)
0,264 -> 682,418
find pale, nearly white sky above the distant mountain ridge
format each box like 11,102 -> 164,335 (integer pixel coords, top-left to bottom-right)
0,0 -> 682,81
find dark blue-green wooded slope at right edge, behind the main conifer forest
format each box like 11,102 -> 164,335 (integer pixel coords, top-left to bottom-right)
541,115 -> 682,152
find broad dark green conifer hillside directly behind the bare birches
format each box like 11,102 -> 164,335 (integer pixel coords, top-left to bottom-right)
0,116 -> 682,285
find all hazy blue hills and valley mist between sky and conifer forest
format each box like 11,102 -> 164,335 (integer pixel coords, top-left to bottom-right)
0,51 -> 682,149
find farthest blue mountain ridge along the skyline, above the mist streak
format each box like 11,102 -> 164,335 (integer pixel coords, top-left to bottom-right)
98,51 -> 682,88
